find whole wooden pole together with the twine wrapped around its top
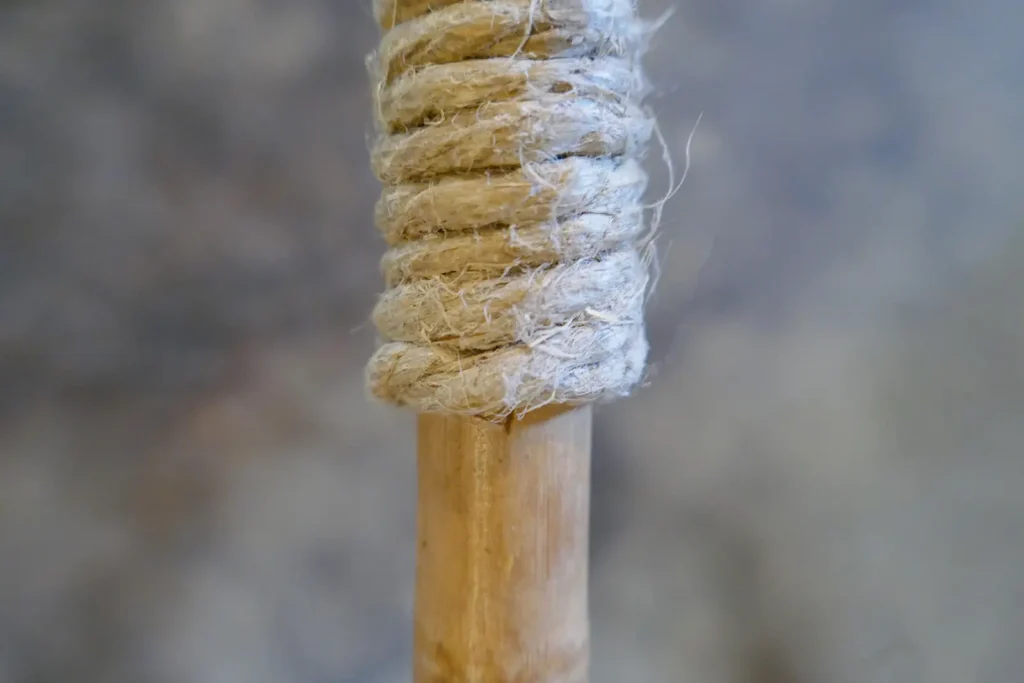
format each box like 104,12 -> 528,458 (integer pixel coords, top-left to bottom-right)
367,0 -> 654,683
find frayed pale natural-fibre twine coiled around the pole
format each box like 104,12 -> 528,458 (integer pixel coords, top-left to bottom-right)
367,0 -> 653,420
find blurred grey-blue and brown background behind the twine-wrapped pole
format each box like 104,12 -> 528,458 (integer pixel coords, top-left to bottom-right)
0,0 -> 1024,683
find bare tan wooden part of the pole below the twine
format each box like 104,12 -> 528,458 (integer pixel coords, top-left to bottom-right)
413,407 -> 592,683
